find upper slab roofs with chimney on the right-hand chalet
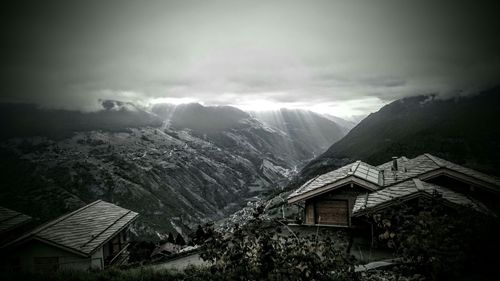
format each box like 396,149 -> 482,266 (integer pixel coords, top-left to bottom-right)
288,153 -> 500,202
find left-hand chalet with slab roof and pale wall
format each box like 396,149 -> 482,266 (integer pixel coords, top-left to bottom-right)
1,200 -> 138,271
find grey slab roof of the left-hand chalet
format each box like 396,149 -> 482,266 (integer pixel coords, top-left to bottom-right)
2,200 -> 138,256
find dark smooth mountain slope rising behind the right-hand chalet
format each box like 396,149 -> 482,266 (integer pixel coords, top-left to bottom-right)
300,87 -> 500,181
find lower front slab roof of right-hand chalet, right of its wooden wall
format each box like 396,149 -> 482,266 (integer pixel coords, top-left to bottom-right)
352,179 -> 489,216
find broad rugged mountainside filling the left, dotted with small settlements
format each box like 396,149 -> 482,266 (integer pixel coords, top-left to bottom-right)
0,101 -> 346,238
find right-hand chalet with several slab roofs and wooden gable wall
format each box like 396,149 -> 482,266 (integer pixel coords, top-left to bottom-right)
288,154 -> 500,227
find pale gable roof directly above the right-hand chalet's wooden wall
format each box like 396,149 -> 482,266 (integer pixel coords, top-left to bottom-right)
288,161 -> 382,200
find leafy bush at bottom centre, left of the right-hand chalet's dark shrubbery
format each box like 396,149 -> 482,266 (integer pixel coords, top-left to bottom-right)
197,207 -> 354,280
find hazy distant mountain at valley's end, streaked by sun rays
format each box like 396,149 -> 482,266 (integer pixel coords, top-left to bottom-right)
250,108 -> 352,157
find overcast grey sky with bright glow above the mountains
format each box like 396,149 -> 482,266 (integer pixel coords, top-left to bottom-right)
0,0 -> 500,117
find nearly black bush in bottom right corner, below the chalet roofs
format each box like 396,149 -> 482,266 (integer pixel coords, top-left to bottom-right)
372,194 -> 500,280
